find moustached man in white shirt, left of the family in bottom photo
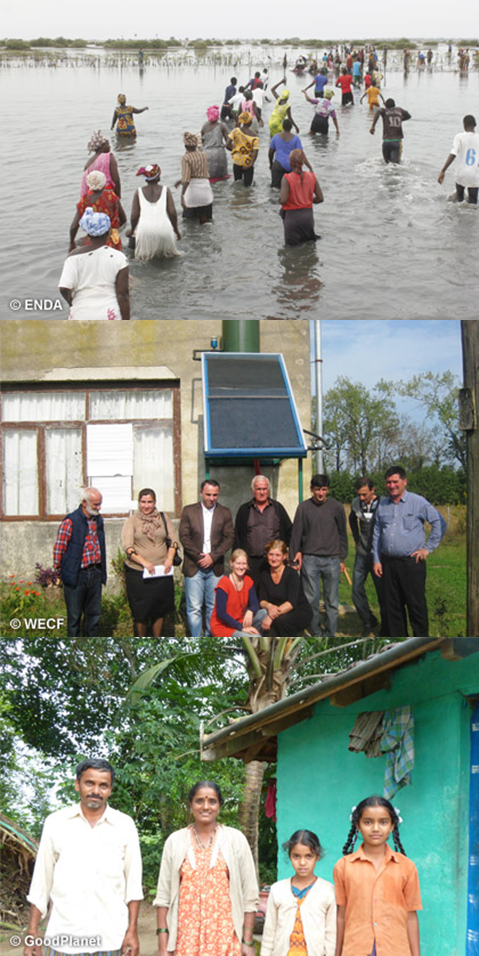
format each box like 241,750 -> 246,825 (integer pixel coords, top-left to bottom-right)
24,758 -> 143,956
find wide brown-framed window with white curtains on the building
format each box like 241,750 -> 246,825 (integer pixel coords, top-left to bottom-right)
1,383 -> 179,519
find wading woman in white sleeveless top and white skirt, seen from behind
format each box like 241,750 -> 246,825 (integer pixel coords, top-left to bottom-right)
128,163 -> 181,260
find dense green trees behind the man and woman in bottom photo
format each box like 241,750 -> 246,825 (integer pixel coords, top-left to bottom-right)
0,636 -> 396,886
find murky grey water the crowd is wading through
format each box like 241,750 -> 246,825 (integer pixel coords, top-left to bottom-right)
0,58 -> 479,319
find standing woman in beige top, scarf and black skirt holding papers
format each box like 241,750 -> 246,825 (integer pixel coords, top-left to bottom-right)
121,488 -> 178,637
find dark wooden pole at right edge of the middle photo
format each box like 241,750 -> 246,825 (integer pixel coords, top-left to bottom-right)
459,319 -> 479,637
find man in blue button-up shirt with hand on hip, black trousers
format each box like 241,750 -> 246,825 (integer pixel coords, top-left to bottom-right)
372,465 -> 446,637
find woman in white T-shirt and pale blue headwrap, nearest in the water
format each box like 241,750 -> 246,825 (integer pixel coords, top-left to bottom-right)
58,206 -> 130,320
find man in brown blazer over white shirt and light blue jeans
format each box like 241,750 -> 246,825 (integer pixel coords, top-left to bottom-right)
179,478 -> 234,637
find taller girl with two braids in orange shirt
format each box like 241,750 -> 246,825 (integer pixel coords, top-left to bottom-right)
334,796 -> 422,956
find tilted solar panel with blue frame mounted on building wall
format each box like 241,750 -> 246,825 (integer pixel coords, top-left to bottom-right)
201,352 -> 308,459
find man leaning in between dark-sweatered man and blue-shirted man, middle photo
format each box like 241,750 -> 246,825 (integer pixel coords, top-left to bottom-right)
349,476 -> 389,637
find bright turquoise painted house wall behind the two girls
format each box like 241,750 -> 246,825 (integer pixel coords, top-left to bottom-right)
278,651 -> 479,956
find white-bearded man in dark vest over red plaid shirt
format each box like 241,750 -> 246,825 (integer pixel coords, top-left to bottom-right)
53,488 -> 106,637
